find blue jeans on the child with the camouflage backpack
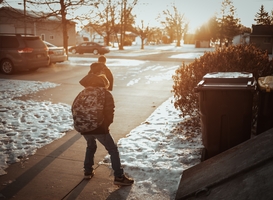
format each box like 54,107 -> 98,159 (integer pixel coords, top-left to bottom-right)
83,133 -> 123,177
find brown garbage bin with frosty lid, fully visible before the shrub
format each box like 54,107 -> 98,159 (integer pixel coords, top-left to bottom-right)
195,72 -> 256,161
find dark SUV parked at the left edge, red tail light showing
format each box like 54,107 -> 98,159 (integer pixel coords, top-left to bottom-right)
0,33 -> 50,74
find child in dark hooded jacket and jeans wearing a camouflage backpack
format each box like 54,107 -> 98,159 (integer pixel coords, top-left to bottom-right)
72,66 -> 134,185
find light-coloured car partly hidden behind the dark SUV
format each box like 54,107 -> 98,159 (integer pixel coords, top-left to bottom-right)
44,41 -> 67,63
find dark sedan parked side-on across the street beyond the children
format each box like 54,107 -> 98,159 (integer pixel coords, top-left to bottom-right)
68,42 -> 110,55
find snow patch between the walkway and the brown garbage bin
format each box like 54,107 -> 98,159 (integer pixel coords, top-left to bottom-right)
100,97 -> 203,200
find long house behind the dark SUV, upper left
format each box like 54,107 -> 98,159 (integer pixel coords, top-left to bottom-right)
0,7 -> 76,46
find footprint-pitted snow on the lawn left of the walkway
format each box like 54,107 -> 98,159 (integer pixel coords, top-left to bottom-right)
0,79 -> 73,175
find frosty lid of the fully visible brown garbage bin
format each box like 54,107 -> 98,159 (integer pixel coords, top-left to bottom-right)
196,72 -> 256,90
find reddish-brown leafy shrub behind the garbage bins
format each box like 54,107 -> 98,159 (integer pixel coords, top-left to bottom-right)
172,44 -> 273,122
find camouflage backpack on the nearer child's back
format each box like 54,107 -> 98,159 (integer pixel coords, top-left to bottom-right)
71,87 -> 105,133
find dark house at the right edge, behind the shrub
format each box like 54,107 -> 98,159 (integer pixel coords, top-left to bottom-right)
250,25 -> 273,54
